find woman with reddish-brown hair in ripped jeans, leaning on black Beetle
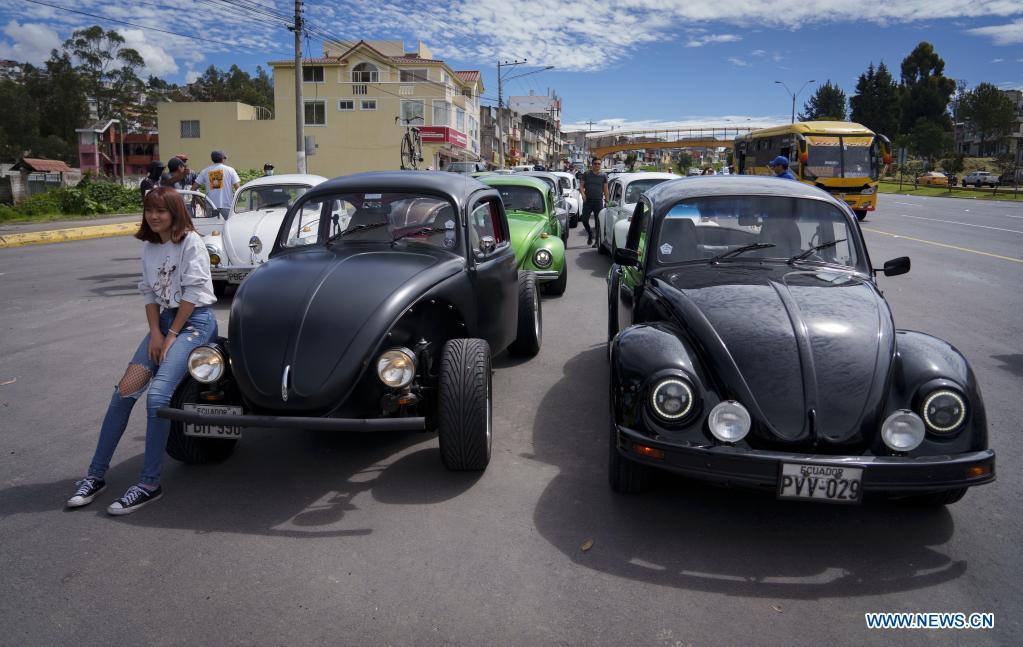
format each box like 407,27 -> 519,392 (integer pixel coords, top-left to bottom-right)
68,186 -> 217,515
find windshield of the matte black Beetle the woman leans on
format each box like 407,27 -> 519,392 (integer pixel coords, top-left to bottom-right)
284,192 -> 458,250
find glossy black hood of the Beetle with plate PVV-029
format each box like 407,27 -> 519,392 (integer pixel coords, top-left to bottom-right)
657,264 -> 895,445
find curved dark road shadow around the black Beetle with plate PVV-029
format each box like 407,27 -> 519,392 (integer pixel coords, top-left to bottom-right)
533,345 -> 967,599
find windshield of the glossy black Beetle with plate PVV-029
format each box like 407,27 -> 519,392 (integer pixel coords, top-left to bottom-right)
657,196 -> 860,267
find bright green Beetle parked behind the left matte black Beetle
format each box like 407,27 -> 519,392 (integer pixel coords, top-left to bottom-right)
478,175 -> 569,295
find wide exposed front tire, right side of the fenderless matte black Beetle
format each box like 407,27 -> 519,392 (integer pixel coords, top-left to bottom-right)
437,339 -> 493,472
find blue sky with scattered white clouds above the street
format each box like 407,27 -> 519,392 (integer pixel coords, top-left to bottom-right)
0,0 -> 1023,129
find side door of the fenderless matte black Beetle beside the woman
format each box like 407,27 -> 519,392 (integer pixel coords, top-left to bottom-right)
466,196 -> 519,353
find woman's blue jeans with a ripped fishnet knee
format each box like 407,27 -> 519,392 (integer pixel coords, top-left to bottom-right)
89,307 -> 217,485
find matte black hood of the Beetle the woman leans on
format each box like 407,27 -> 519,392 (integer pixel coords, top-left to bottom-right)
228,245 -> 464,412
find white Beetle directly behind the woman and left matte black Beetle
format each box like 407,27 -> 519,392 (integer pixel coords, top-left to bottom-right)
203,174 -> 326,296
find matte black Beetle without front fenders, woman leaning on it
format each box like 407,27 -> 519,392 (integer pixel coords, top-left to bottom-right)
160,172 -> 541,470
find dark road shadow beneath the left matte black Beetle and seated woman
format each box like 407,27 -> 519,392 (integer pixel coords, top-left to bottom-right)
0,430 -> 481,537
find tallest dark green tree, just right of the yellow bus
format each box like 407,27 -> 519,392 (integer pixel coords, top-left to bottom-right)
901,42 -> 955,133
